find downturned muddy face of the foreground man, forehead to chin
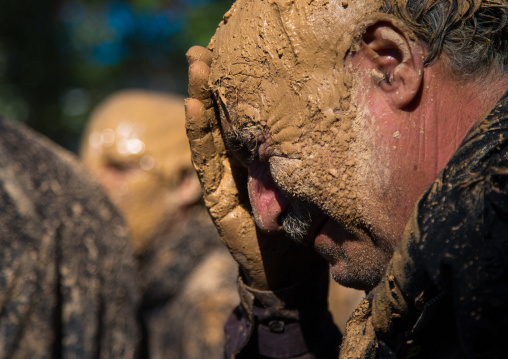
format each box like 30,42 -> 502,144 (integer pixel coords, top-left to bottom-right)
210,0 -> 394,289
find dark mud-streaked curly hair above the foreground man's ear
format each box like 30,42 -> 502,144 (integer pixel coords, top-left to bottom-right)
383,0 -> 508,79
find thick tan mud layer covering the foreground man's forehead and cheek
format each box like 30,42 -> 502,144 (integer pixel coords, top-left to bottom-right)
210,0 -> 382,228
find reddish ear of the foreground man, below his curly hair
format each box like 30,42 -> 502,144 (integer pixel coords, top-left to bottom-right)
353,21 -> 424,109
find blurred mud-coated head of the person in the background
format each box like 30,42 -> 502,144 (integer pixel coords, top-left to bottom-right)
80,90 -> 200,254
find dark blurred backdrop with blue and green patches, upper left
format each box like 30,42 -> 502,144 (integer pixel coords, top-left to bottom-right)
0,0 -> 234,151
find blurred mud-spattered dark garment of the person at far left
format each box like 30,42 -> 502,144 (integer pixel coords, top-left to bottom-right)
0,120 -> 139,359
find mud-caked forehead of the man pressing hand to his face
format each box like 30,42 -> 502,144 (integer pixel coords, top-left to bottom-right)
210,0 -> 381,134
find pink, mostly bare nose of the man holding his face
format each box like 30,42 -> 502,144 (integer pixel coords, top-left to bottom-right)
248,162 -> 288,232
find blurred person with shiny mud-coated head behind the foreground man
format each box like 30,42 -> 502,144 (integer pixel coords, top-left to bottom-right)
80,90 -> 239,358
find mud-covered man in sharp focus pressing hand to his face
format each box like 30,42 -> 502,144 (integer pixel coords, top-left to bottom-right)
187,0 -> 508,358
